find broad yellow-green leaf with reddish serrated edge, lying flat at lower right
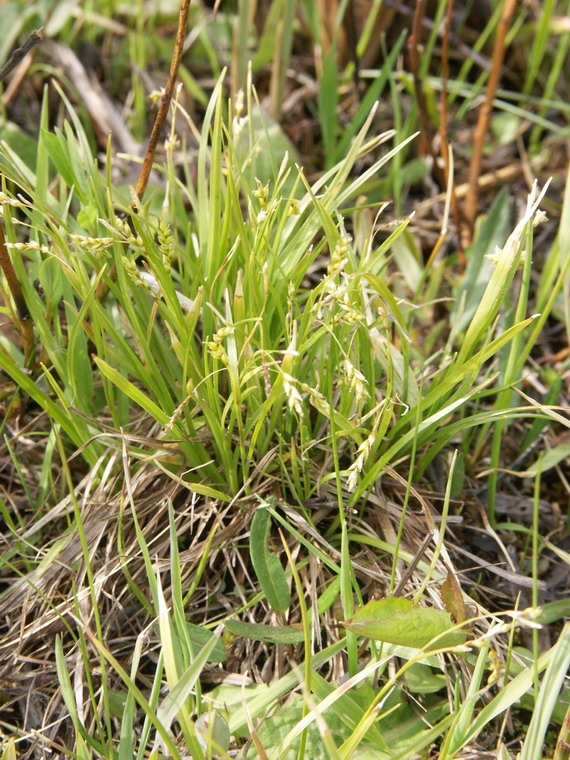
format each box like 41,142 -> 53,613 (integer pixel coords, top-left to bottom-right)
342,596 -> 467,649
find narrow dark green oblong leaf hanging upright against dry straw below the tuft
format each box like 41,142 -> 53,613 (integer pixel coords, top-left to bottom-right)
249,507 -> 291,611
